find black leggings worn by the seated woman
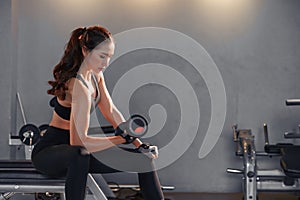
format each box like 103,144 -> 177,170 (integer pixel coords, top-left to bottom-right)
32,128 -> 164,200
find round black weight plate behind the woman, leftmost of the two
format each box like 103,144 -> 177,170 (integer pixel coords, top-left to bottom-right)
19,124 -> 40,145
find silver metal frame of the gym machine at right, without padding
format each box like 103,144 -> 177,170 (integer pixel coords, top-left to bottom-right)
227,127 -> 300,200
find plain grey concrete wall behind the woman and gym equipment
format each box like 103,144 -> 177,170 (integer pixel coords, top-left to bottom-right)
0,0 -> 300,192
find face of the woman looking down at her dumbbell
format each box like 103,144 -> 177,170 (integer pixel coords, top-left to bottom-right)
84,40 -> 115,74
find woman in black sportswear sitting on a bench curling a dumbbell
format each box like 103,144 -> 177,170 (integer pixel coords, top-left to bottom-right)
32,26 -> 164,200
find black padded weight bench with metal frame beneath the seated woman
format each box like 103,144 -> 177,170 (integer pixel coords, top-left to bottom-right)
0,160 -> 107,200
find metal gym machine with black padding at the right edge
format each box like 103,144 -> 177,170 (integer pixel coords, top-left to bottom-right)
227,100 -> 300,200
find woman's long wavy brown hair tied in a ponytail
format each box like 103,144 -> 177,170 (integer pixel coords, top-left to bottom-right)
47,26 -> 112,100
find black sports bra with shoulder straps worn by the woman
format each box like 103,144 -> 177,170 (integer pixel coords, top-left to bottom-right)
49,74 -> 100,120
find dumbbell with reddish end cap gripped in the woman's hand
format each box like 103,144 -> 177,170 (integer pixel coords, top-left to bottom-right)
116,114 -> 148,138
